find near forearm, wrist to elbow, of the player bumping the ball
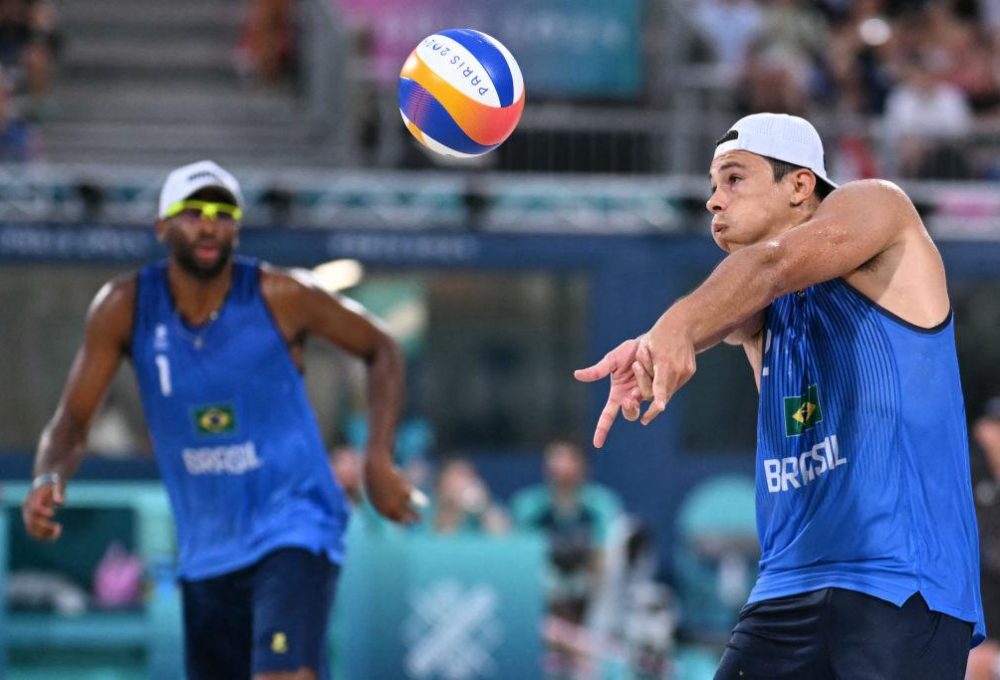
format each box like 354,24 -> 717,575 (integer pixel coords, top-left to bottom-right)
651,242 -> 782,352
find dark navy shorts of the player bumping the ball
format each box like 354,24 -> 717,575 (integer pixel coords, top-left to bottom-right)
715,588 -> 972,680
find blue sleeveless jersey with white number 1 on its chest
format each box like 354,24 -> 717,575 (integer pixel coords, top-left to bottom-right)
131,258 -> 347,579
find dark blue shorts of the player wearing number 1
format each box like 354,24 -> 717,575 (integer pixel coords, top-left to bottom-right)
181,548 -> 340,680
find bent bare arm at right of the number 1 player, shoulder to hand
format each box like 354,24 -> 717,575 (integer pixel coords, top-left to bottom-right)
261,267 -> 419,522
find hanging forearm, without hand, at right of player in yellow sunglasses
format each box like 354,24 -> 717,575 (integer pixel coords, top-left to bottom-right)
367,336 -> 406,462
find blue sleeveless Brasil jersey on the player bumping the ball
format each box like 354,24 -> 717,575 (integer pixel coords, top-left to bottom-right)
750,279 -> 984,643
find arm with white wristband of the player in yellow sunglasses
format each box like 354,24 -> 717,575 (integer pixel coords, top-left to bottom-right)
21,277 -> 135,540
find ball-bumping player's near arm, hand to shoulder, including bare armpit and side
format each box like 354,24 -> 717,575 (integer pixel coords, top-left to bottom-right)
643,180 -> 948,423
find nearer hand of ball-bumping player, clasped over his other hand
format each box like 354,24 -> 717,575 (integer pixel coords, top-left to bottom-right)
632,316 -> 697,425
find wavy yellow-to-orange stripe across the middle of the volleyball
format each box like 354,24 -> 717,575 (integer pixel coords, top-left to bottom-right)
399,50 -> 524,146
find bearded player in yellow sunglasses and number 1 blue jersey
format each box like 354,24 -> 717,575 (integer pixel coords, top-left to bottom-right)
23,161 -> 416,680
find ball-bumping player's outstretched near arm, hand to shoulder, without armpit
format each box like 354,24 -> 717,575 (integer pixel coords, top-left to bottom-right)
637,180 -> 916,424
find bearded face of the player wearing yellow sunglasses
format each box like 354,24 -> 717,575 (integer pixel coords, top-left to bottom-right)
159,194 -> 239,279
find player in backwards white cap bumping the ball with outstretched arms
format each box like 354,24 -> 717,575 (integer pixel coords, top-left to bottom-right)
576,113 -> 984,680
